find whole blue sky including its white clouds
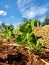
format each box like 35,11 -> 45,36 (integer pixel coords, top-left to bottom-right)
0,0 -> 49,27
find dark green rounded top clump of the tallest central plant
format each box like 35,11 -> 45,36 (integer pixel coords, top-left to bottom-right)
19,20 -> 34,33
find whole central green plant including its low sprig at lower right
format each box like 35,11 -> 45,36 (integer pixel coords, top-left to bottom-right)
17,20 -> 44,52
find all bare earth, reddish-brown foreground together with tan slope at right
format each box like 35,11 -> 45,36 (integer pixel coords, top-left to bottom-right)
0,25 -> 49,65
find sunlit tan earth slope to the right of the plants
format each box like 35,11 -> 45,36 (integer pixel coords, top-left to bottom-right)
34,25 -> 49,49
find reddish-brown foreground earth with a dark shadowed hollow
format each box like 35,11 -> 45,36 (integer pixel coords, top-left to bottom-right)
0,45 -> 49,65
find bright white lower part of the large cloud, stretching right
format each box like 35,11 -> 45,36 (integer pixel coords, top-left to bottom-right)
23,7 -> 47,18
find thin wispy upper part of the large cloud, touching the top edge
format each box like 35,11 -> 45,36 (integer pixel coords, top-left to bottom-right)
17,0 -> 34,11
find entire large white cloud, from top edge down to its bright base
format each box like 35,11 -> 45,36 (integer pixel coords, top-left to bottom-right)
18,0 -> 48,18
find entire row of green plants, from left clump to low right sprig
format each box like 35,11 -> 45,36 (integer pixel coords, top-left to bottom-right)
0,20 -> 44,52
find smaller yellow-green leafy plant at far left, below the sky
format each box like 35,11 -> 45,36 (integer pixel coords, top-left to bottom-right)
0,24 -> 14,39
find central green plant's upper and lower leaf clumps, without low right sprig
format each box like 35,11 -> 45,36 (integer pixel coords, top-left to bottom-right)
17,20 -> 36,44
